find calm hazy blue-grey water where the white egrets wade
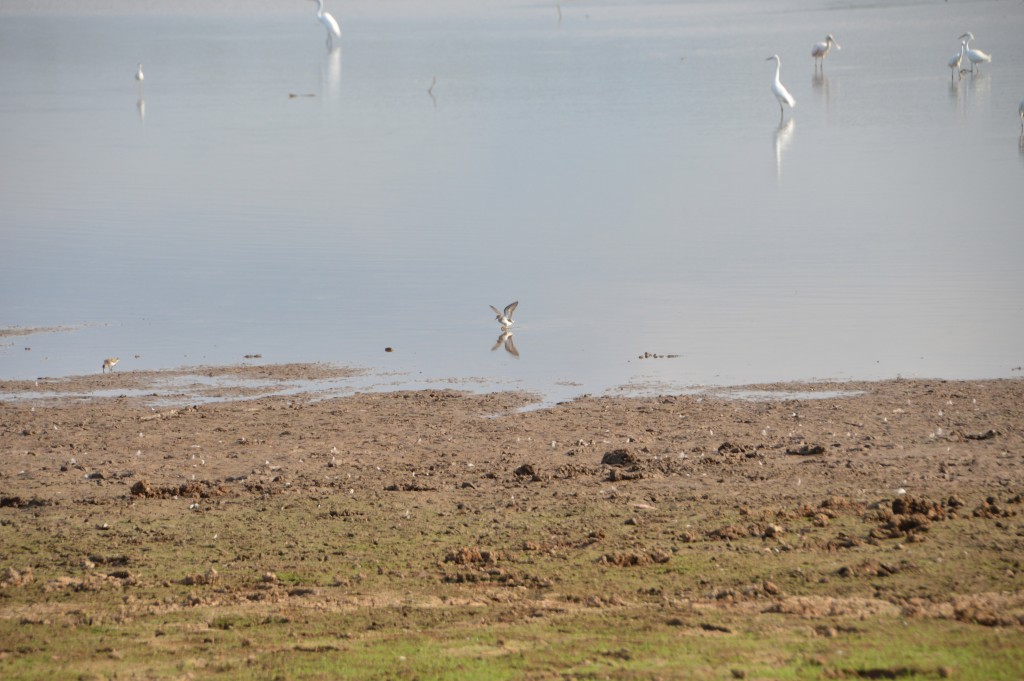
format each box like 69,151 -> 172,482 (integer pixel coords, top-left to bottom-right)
0,0 -> 1024,396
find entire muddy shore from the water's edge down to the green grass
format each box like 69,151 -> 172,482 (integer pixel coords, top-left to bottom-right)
0,365 -> 1024,679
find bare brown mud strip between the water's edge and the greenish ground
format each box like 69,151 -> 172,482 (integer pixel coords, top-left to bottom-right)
6,365 -> 1024,505
